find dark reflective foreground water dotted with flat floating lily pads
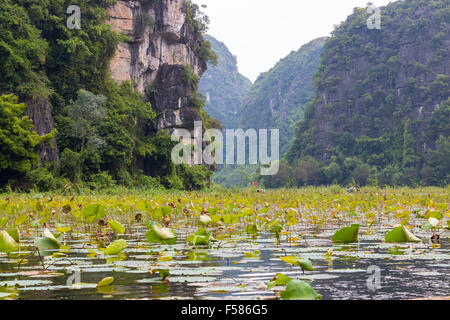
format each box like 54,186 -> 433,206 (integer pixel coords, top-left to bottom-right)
0,227 -> 450,300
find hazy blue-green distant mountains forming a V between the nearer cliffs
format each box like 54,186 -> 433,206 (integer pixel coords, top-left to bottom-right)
207,38 -> 327,187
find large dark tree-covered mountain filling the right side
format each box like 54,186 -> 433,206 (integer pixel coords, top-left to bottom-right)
284,0 -> 450,185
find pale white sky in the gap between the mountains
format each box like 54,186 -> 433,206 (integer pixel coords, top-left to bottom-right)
193,0 -> 394,81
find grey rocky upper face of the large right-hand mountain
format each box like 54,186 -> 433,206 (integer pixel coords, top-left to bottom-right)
306,0 -> 450,161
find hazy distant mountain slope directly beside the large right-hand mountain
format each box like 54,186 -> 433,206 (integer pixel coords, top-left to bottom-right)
239,38 -> 327,154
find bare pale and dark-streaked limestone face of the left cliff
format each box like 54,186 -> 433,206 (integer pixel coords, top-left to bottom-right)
108,0 -> 207,130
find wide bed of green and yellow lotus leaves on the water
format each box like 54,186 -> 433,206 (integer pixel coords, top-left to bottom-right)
0,187 -> 450,300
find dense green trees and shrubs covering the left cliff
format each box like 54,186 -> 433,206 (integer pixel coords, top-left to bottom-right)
0,0 -> 215,190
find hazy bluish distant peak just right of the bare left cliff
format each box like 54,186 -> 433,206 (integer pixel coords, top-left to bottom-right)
199,35 -> 252,129
